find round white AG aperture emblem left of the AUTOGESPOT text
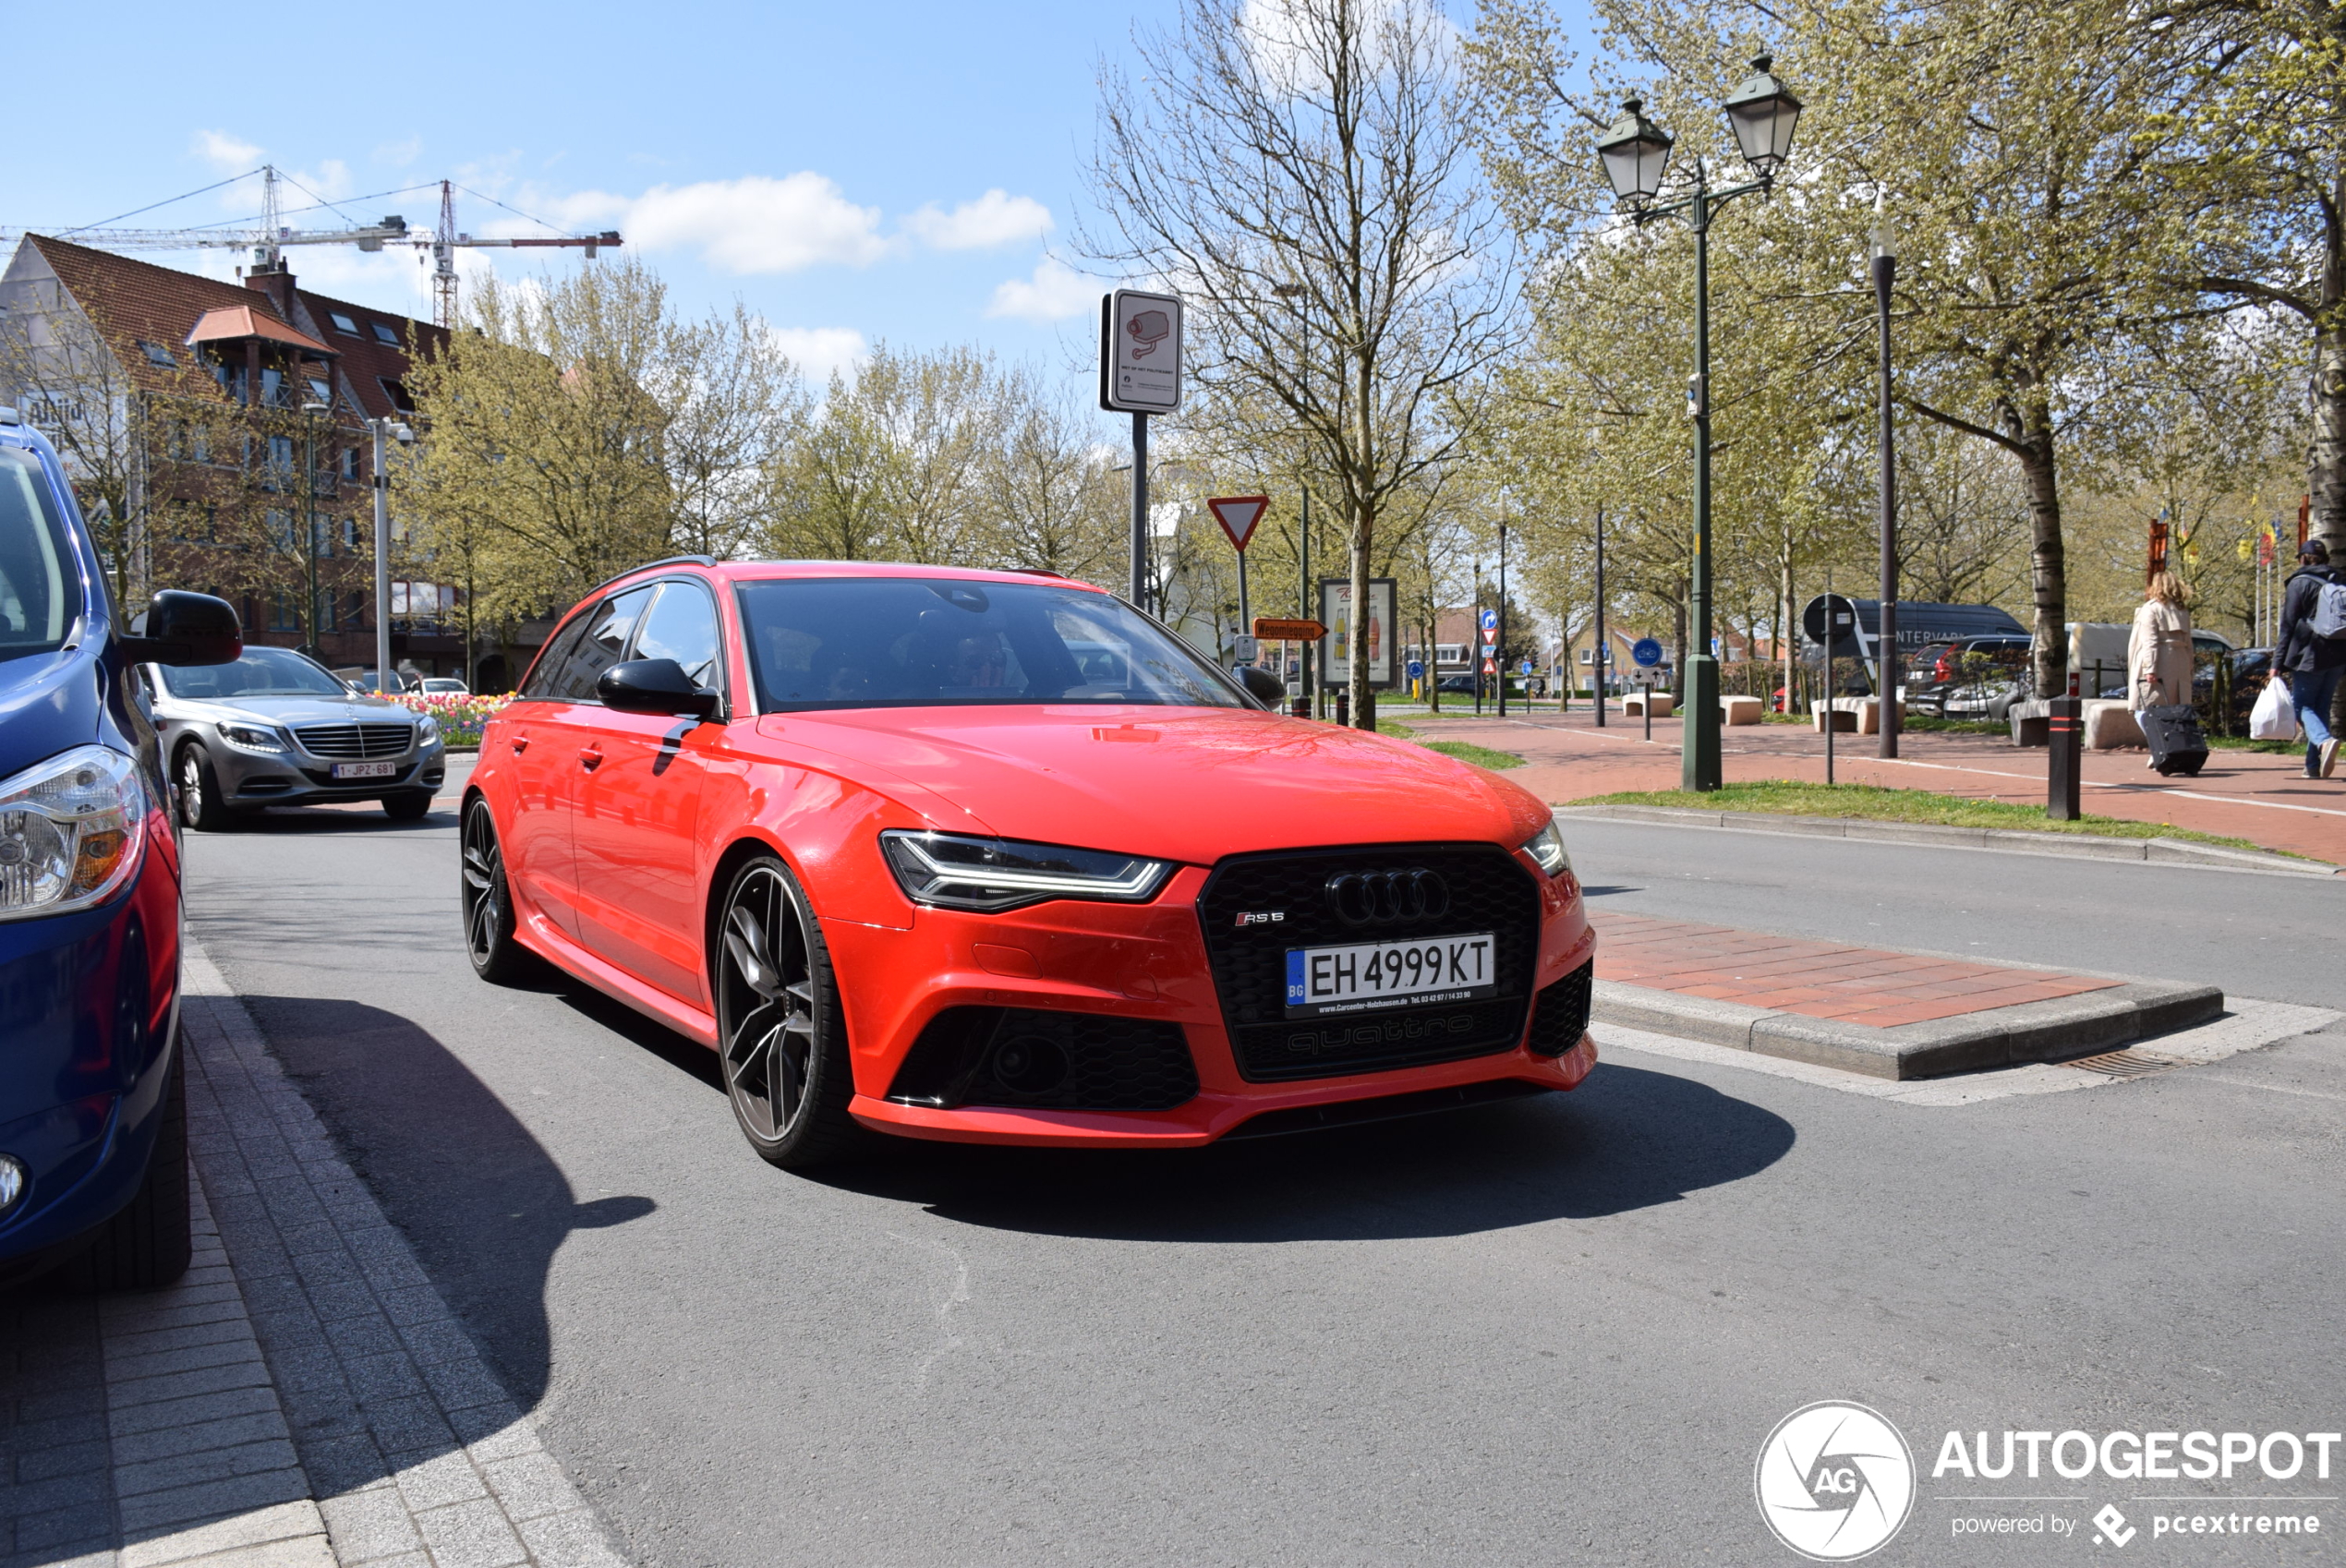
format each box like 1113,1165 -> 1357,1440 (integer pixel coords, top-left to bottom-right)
1752,1399 -> 1915,1563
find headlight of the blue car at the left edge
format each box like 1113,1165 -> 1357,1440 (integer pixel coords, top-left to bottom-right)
0,745 -> 148,921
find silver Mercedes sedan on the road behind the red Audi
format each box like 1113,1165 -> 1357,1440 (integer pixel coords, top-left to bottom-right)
139,645 -> 448,832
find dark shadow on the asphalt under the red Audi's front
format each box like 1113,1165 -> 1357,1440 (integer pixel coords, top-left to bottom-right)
816,1064 -> 1795,1242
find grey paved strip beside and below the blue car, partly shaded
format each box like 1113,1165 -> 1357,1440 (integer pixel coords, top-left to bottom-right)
0,942 -> 622,1568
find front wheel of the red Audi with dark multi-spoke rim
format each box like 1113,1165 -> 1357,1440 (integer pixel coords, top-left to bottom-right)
711,855 -> 870,1170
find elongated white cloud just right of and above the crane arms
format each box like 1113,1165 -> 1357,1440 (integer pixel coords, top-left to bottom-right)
600,171 -> 889,271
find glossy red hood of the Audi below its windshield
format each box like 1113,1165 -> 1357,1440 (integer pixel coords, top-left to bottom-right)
757,706 -> 1548,865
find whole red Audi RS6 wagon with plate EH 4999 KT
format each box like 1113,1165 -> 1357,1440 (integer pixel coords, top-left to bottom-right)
462,558 -> 1595,1167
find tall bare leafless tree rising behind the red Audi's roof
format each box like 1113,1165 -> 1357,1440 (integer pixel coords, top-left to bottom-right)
1083,0 -> 1513,727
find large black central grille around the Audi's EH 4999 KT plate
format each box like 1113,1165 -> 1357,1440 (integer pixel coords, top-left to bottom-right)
1196,844 -> 1539,1083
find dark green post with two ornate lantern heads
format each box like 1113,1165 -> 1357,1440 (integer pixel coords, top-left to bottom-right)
1598,54 -> 1799,790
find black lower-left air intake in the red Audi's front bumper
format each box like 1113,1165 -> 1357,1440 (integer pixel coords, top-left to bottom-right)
887,1007 -> 1196,1111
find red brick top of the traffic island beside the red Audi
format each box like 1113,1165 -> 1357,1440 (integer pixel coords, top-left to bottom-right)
1590,911 -> 2121,1029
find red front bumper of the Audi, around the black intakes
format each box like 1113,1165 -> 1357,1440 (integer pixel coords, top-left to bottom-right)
824,867 -> 1595,1149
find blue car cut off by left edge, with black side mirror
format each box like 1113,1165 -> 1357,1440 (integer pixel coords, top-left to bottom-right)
0,408 -> 244,1289
